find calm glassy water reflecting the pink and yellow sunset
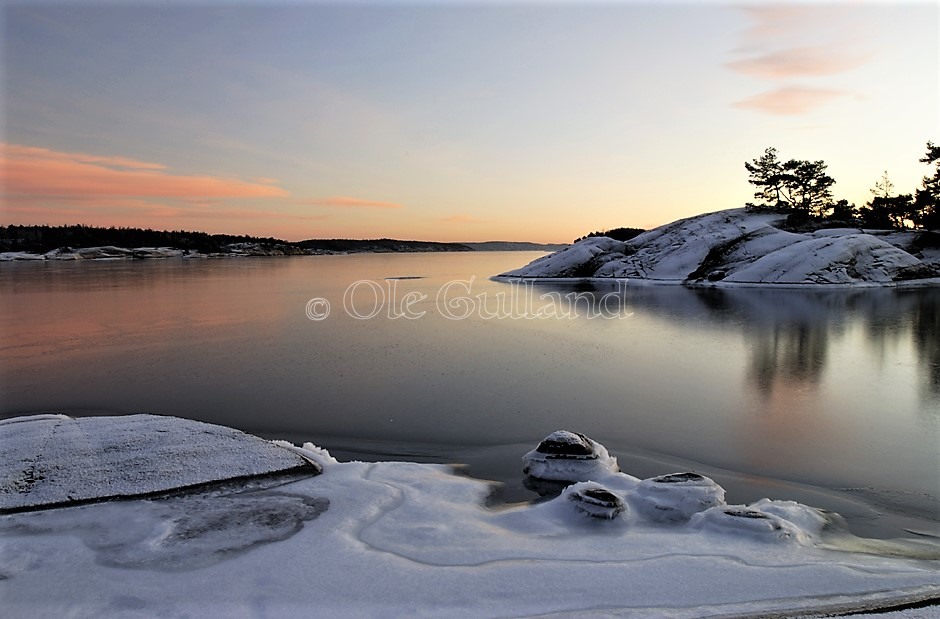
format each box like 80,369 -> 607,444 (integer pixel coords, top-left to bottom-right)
0,252 -> 940,536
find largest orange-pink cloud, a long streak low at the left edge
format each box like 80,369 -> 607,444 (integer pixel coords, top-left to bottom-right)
0,144 -> 288,200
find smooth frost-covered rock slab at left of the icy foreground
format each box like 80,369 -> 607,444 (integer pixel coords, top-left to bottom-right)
0,415 -> 319,513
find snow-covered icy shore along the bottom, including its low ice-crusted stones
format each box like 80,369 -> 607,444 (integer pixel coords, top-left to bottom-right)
0,424 -> 940,617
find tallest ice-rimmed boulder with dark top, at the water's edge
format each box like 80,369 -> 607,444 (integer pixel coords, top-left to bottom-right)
522,430 -> 619,482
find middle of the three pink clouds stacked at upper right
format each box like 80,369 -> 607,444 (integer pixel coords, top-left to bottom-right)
726,45 -> 868,79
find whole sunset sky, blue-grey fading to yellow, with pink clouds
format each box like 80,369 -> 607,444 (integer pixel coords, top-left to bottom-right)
0,0 -> 940,243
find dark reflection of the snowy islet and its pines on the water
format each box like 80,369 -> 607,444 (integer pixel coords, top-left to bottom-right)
520,281 -> 940,400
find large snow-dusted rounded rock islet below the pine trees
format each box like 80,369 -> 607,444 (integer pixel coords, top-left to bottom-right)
502,209 -> 940,285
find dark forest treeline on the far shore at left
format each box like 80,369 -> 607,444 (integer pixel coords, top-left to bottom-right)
0,224 -> 294,254
